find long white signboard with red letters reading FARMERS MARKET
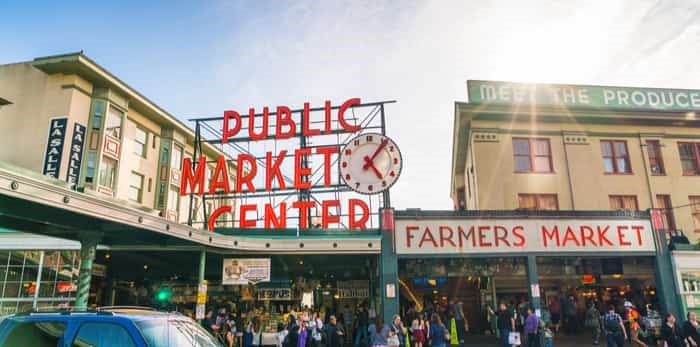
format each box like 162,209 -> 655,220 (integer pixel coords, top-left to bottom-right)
395,218 -> 655,254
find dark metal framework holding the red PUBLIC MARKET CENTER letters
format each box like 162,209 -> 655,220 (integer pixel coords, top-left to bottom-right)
188,100 -> 396,229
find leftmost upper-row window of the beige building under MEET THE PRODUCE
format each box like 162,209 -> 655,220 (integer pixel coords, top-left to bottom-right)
513,138 -> 553,173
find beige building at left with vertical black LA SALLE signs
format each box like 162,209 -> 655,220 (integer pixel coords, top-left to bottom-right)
0,53 -> 234,227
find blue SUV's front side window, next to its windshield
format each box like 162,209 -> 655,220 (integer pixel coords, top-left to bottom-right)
72,322 -> 136,347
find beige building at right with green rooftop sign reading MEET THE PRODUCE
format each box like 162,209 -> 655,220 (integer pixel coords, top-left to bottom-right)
451,81 -> 700,241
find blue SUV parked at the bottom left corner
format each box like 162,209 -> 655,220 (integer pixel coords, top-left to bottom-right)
0,307 -> 221,347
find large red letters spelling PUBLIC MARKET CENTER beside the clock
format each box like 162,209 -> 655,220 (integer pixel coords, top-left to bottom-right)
180,98 -> 370,230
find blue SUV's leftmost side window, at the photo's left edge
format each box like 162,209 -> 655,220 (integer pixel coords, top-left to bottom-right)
0,321 -> 66,347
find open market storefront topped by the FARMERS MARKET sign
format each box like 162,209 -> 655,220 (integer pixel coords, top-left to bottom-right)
382,211 -> 672,333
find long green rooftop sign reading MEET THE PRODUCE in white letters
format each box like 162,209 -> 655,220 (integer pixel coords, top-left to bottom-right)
467,80 -> 700,112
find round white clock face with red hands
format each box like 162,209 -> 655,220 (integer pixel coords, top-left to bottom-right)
339,133 -> 403,194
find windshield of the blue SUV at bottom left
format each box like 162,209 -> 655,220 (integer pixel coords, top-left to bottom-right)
136,319 -> 221,347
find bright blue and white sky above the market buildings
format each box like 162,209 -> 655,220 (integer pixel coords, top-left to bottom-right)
0,0 -> 700,209
